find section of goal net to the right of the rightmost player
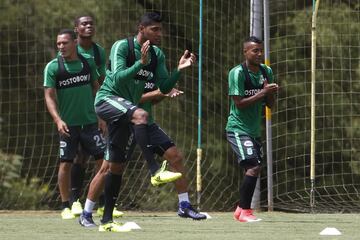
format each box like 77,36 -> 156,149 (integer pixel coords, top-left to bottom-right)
269,1 -> 360,212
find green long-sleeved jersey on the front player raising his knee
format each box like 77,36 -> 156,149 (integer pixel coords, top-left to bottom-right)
95,38 -> 180,105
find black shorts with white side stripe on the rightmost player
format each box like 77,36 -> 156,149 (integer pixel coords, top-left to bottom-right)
226,132 -> 263,166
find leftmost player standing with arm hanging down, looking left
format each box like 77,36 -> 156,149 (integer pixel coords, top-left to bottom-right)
44,29 -> 106,219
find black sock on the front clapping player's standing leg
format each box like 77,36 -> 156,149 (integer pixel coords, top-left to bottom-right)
101,172 -> 122,223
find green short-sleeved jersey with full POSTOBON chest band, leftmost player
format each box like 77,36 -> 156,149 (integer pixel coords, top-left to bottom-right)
44,54 -> 99,126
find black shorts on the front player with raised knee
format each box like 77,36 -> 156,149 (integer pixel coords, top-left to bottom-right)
95,96 -> 138,162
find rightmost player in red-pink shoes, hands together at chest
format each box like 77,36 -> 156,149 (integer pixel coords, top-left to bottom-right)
226,36 -> 279,222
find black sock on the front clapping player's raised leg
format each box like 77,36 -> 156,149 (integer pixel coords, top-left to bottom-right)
134,124 -> 159,176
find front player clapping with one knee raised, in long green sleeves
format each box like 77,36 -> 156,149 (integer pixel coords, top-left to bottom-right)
89,13 -> 201,232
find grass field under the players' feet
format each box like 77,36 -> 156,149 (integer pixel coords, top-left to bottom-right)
0,211 -> 360,240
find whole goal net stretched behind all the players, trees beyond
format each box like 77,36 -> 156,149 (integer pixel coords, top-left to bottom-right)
0,0 -> 360,211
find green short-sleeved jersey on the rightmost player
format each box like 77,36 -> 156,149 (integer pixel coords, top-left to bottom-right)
226,64 -> 274,138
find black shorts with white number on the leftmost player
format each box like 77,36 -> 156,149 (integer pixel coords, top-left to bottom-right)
60,123 -> 106,162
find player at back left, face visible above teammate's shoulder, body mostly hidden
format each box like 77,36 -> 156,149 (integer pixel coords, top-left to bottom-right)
71,15 -> 124,217
